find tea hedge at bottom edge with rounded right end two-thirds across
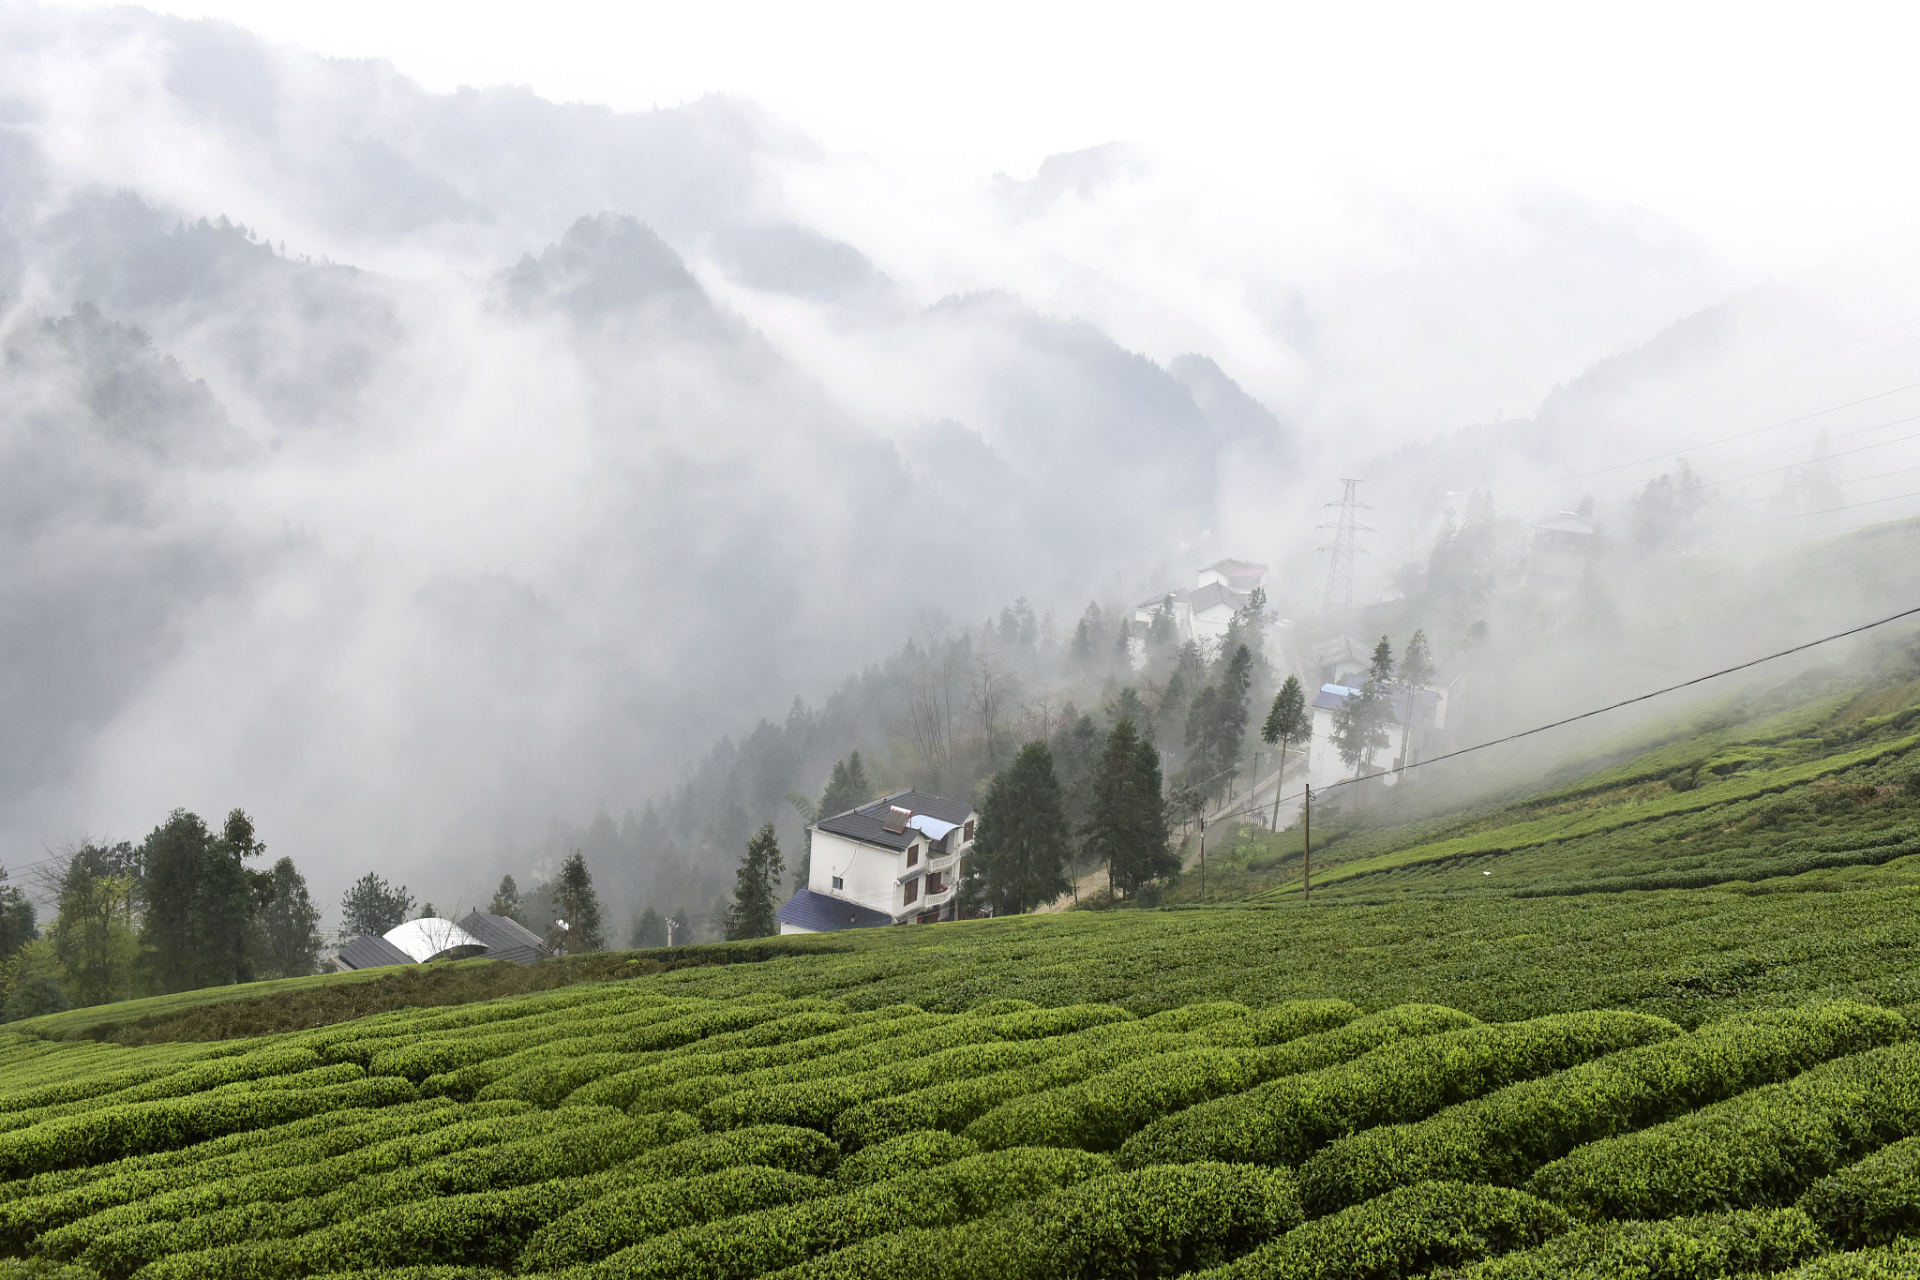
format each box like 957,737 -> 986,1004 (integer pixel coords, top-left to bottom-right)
778,1165 -> 1300,1280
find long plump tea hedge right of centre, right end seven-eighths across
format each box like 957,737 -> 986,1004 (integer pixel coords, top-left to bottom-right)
1119,1006 -> 1680,1167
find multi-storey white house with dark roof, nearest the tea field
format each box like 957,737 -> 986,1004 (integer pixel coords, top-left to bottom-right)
780,791 -> 979,933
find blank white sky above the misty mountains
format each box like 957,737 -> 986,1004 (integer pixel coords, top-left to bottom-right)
41,0 -> 1920,271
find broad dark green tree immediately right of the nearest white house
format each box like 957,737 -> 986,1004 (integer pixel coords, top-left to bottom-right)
973,743 -> 1073,915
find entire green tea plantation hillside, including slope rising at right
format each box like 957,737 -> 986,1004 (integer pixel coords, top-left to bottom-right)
0,660 -> 1920,1280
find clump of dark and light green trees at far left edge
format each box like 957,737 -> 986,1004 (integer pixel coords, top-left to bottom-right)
0,808 -> 321,1019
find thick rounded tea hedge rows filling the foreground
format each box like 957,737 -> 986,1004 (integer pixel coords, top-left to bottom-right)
0,974 -> 1920,1280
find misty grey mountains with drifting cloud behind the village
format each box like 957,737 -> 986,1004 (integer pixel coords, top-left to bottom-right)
0,8 -> 1904,932
